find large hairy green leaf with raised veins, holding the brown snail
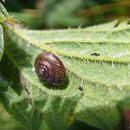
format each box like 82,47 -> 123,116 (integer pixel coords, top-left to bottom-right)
0,21 -> 130,130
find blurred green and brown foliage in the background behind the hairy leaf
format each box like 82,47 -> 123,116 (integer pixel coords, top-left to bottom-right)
0,0 -> 130,130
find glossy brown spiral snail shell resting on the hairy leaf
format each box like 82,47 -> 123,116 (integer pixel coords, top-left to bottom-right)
34,51 -> 66,86
